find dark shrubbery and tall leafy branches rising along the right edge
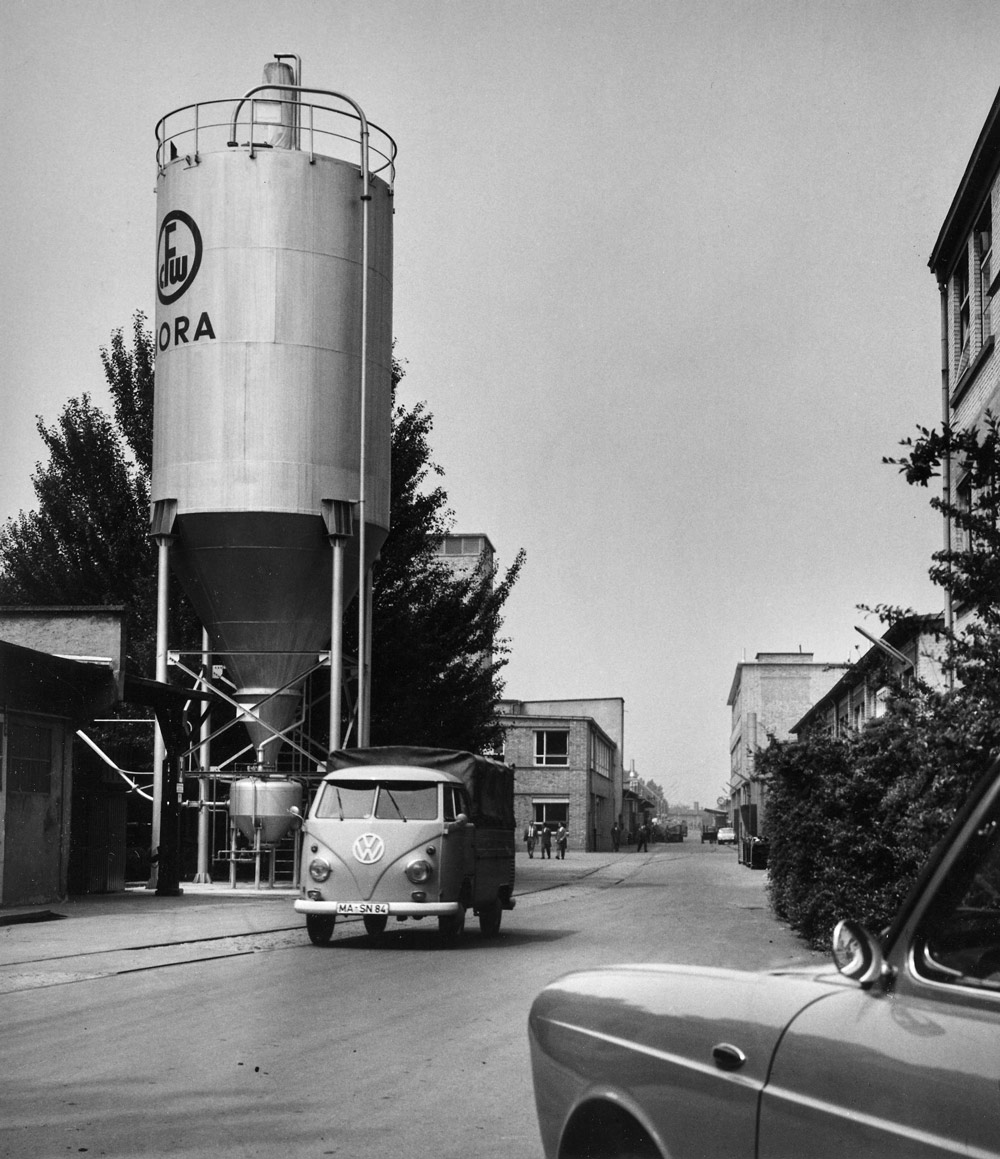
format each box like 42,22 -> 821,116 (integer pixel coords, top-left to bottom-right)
756,415 -> 1000,945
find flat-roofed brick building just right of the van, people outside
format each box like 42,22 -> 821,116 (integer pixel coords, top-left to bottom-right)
497,697 -> 625,850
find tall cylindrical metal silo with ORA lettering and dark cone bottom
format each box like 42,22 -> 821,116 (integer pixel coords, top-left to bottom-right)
151,63 -> 395,745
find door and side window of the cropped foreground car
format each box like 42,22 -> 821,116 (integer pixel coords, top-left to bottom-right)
758,793 -> 1000,1159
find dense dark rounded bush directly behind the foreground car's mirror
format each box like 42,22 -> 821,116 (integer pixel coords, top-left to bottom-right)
757,690 -> 997,947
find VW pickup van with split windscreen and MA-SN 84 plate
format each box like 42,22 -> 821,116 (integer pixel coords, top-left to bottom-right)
295,746 -> 514,946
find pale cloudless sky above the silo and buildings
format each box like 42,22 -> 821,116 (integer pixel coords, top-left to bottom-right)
0,0 -> 1000,804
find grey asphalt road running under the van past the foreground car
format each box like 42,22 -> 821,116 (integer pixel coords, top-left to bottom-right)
0,843 -> 810,1159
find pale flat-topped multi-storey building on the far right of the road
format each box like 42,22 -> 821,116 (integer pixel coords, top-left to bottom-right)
728,651 -> 848,862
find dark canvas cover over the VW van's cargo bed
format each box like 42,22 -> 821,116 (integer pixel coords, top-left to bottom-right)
327,745 -> 514,829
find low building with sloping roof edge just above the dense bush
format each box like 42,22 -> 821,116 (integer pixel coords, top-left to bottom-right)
791,614 -> 946,736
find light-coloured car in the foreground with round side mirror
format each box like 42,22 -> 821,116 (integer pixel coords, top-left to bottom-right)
528,763 -> 1000,1159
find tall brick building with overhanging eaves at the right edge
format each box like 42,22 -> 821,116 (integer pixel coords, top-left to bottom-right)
928,92 -> 1000,625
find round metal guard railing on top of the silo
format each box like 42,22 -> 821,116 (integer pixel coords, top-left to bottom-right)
156,95 -> 396,189
